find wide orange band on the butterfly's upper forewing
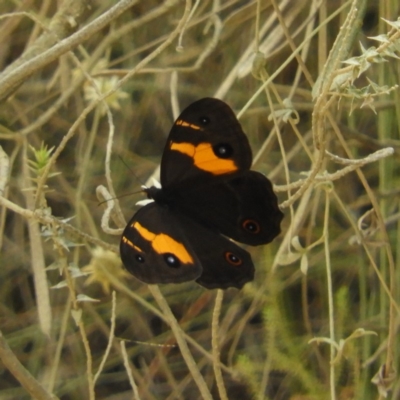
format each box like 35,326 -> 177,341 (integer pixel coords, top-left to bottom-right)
170,142 -> 238,175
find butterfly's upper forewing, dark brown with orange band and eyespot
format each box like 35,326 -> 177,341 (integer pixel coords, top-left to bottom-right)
161,98 -> 252,189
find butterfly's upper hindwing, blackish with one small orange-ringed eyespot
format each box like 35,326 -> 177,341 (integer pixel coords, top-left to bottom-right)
166,171 -> 283,246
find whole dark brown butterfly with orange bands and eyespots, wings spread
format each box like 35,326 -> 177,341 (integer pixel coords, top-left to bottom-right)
120,98 -> 283,289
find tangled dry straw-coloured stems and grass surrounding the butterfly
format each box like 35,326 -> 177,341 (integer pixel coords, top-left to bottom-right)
0,0 -> 400,400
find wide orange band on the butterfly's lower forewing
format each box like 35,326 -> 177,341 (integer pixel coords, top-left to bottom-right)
133,222 -> 194,264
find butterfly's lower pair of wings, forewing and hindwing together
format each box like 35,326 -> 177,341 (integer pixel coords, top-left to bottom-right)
120,203 -> 254,289
